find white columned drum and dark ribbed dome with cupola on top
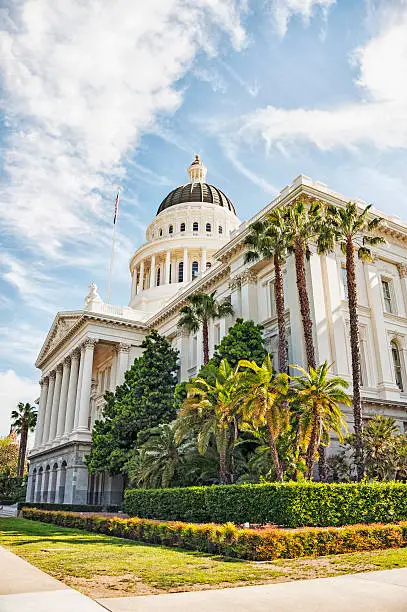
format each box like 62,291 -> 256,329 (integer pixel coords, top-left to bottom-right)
129,155 -> 240,312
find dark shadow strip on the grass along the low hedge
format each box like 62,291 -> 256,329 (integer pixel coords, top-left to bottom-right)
2,523 -> 249,563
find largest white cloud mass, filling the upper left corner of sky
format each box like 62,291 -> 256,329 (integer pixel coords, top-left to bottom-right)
0,0 -> 245,257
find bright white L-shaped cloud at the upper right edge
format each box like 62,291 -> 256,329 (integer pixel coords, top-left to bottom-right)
225,3 -> 407,150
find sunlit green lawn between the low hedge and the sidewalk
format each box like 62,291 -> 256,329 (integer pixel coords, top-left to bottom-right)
0,518 -> 407,598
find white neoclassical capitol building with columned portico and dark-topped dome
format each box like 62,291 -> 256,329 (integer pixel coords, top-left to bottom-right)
27,155 -> 407,504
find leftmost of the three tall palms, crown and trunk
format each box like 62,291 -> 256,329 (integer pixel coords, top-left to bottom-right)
244,209 -> 288,372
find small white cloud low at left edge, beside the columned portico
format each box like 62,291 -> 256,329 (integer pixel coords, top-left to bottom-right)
0,370 -> 40,436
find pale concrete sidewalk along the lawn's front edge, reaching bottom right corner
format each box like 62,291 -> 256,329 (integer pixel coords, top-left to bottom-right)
100,568 -> 407,612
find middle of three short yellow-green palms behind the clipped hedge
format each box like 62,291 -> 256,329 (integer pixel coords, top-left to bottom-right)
238,355 -> 289,481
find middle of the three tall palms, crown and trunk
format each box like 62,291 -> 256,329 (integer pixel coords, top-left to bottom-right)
282,197 -> 322,368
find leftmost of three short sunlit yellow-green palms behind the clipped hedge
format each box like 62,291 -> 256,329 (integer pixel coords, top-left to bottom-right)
177,359 -> 240,484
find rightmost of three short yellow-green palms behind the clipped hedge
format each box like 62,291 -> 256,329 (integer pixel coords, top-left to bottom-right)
291,361 -> 351,478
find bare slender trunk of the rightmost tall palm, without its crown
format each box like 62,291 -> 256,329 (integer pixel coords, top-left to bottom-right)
346,237 -> 364,480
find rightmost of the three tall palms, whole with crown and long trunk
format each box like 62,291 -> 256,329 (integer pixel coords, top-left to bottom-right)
318,202 -> 385,480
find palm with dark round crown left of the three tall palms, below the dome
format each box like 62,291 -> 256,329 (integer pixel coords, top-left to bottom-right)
178,291 -> 233,365
